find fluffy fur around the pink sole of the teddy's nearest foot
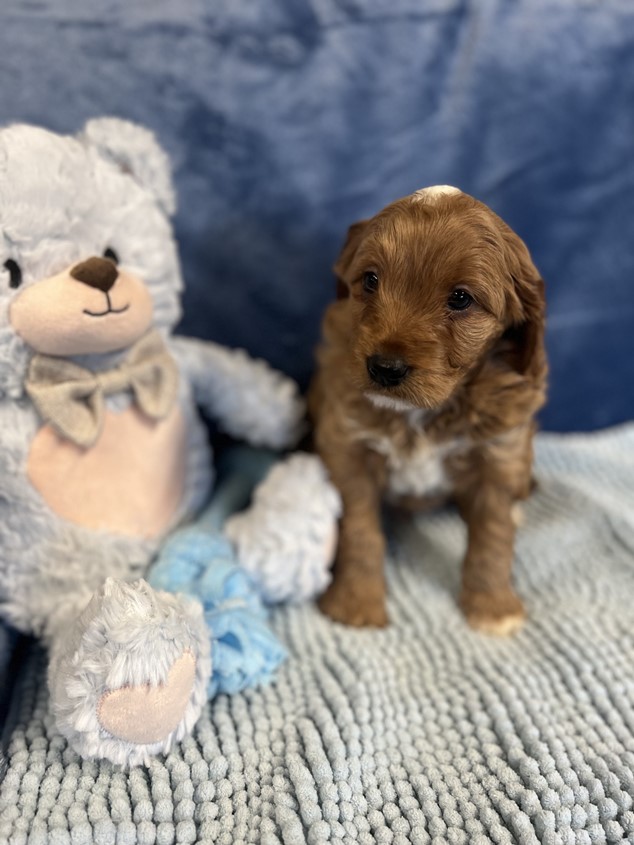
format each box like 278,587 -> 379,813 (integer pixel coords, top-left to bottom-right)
49,578 -> 211,765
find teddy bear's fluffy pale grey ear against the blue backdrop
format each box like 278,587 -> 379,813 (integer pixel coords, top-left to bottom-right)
79,117 -> 176,216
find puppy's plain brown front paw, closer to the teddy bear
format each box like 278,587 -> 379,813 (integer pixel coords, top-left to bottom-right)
317,578 -> 389,628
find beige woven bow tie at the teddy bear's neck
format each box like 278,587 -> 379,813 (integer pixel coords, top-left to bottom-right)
24,331 -> 178,448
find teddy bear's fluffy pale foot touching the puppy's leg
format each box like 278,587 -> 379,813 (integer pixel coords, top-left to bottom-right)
225,452 -> 341,603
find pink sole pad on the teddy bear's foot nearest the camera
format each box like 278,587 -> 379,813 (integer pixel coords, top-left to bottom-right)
98,651 -> 196,745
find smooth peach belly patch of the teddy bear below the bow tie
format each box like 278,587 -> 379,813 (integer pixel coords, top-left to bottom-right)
27,407 -> 186,538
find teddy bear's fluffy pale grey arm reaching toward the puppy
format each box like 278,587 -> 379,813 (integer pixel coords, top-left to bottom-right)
170,337 -> 304,449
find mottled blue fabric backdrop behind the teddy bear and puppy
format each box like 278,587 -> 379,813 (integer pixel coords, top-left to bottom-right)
0,0 -> 634,430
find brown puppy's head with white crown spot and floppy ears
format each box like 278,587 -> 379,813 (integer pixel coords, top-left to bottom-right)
335,187 -> 543,410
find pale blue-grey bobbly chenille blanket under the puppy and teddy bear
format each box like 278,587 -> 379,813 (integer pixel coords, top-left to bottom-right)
0,426 -> 634,845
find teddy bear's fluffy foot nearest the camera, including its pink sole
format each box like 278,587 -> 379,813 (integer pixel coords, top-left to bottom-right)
49,579 -> 211,765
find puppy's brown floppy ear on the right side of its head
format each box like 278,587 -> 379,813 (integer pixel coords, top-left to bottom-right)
500,224 -> 546,376
